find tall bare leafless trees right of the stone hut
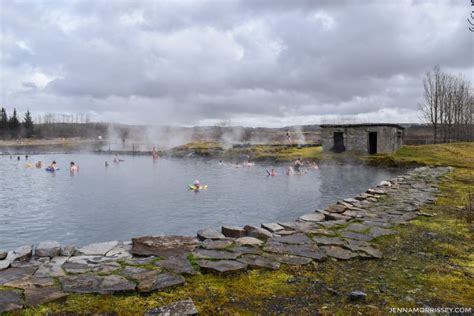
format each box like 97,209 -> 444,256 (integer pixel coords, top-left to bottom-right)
420,66 -> 474,143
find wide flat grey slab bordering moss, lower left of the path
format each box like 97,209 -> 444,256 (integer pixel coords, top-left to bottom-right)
59,274 -> 135,294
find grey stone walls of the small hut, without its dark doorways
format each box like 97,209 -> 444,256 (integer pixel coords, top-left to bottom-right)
321,125 -> 403,153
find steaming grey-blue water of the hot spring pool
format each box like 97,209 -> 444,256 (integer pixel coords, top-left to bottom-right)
0,154 -> 400,249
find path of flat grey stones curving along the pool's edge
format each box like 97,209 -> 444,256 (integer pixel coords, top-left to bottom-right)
0,167 -> 451,315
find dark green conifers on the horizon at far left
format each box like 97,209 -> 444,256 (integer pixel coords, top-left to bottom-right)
0,107 -> 34,139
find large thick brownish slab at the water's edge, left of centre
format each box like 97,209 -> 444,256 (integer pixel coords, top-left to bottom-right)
131,235 -> 198,257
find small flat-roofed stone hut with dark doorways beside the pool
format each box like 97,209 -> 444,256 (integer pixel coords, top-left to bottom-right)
321,124 -> 405,154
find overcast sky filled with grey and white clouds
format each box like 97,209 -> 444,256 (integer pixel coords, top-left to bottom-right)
0,0 -> 474,126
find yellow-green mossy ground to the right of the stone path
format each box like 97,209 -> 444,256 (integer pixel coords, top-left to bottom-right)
19,144 -> 474,315
